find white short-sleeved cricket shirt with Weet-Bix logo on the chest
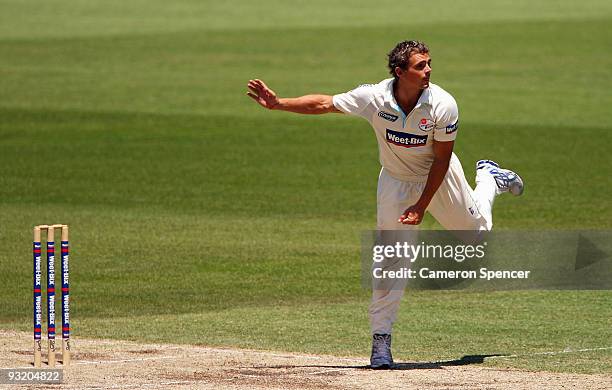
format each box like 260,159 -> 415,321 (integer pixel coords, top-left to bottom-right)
333,78 -> 459,182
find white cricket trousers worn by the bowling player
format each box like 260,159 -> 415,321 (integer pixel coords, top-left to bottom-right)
369,153 -> 497,334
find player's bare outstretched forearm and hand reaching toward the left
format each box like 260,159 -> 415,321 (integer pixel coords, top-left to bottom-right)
247,79 -> 341,114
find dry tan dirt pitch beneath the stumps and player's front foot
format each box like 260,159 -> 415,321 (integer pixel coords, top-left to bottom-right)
0,331 -> 612,390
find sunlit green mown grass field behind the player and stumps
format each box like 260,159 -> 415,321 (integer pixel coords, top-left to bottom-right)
0,0 -> 612,373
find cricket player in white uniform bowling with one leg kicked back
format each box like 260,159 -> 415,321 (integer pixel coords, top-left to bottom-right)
247,41 -> 523,368
